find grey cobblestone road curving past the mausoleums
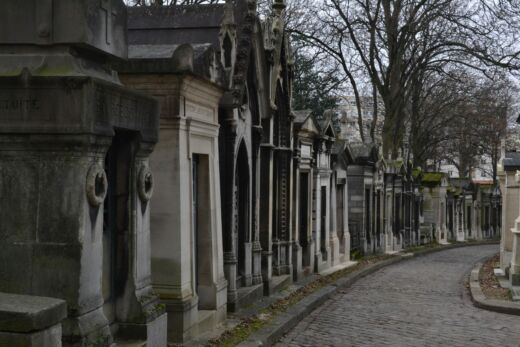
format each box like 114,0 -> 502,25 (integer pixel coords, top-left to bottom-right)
276,245 -> 520,347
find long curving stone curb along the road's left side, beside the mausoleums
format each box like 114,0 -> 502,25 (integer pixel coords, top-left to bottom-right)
238,241 -> 499,347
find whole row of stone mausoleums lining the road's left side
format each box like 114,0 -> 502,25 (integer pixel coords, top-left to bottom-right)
0,0 -> 500,346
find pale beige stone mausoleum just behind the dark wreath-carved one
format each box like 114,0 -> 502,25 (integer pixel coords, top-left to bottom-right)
118,42 -> 227,341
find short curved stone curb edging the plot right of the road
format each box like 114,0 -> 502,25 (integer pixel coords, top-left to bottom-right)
469,263 -> 520,316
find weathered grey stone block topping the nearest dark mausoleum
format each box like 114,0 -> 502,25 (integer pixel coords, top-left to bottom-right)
0,0 -> 127,58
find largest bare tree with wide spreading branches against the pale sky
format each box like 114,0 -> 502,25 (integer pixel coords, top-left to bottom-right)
294,0 -> 519,157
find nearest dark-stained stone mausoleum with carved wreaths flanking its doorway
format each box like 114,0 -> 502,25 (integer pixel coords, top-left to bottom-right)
0,0 -> 166,346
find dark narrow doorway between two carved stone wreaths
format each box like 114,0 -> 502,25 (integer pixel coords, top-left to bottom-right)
102,132 -> 134,323
